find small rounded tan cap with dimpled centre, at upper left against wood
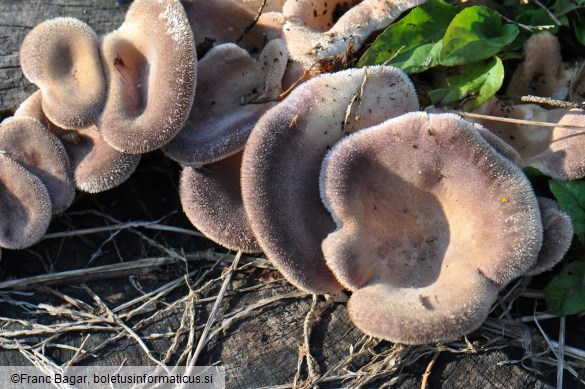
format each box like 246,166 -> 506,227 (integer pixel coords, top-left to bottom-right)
20,18 -> 106,129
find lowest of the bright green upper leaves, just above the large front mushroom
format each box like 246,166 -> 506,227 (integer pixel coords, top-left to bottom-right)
429,57 -> 504,111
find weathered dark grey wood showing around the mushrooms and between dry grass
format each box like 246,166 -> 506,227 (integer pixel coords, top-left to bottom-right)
0,0 -> 568,389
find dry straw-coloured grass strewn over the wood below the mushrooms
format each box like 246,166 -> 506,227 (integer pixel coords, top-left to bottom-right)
0,212 -> 585,388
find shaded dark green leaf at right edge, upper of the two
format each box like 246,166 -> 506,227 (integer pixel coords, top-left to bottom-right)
548,180 -> 585,245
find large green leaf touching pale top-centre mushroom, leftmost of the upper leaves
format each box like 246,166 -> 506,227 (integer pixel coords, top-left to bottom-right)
358,0 -> 461,74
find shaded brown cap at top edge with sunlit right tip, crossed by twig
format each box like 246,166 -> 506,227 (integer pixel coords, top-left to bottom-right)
182,0 -> 284,58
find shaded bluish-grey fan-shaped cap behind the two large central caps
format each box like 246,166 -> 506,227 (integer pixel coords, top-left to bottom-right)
164,39 -> 287,167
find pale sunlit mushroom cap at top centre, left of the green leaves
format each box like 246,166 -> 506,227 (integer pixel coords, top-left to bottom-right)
282,0 -> 426,67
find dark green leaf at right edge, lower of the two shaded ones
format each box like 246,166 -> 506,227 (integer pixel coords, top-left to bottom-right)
544,261 -> 585,316
